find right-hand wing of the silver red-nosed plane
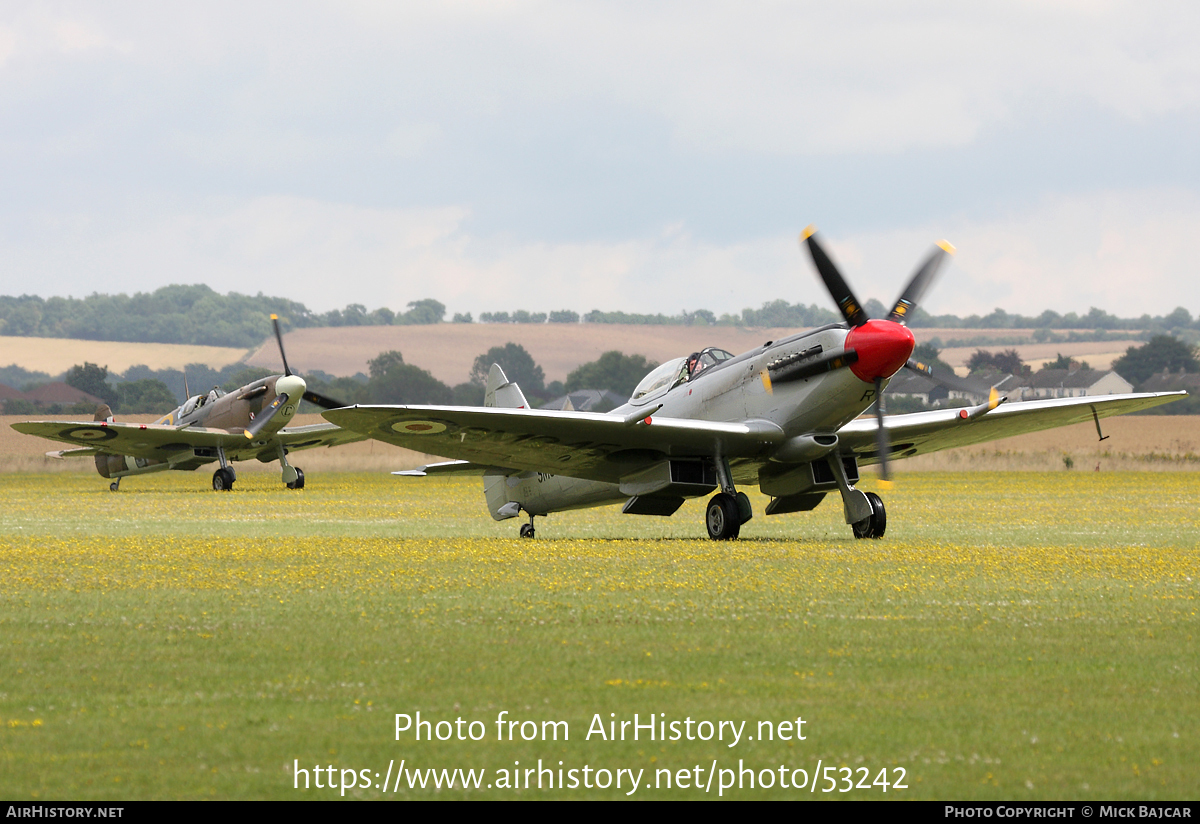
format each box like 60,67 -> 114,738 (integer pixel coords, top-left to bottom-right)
838,392 -> 1187,464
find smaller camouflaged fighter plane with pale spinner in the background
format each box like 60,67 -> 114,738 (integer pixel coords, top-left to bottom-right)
12,314 -> 365,492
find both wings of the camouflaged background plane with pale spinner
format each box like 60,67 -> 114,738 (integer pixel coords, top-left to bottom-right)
12,421 -> 365,461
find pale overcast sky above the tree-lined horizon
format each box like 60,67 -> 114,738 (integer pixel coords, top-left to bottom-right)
0,0 -> 1200,315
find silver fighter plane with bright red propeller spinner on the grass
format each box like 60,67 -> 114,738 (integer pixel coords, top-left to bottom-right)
323,228 -> 1187,540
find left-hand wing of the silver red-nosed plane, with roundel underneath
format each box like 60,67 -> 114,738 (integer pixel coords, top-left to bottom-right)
322,407 -> 784,482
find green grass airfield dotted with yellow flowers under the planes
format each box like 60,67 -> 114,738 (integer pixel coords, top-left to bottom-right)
0,471 -> 1200,800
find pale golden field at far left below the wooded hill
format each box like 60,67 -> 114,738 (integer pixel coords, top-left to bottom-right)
0,336 -> 246,375
